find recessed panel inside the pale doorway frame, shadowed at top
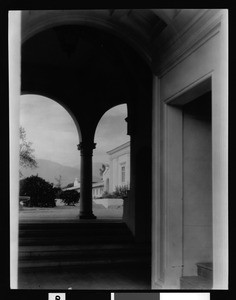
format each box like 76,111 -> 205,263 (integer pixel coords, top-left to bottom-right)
183,93 -> 213,276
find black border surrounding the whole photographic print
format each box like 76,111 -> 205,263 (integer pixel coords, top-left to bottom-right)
0,0 -> 232,300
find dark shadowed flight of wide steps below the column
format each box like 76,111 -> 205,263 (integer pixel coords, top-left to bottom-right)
19,222 -> 151,269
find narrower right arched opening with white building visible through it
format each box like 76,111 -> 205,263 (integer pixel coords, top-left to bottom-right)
93,104 -> 130,219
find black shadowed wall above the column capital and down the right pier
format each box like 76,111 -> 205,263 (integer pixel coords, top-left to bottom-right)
21,25 -> 152,244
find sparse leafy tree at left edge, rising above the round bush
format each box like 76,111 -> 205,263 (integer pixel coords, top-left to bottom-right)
20,126 -> 37,177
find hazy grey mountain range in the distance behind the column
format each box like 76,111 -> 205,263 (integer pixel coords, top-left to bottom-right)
22,159 -> 102,187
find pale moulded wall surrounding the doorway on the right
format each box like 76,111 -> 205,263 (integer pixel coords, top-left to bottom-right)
152,10 -> 228,289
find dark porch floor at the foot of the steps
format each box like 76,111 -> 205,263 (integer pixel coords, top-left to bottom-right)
18,266 -> 151,290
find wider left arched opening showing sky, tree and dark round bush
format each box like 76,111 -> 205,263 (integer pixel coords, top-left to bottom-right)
19,94 -> 80,222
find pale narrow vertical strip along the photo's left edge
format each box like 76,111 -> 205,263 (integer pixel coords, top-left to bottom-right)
8,11 -> 21,289
